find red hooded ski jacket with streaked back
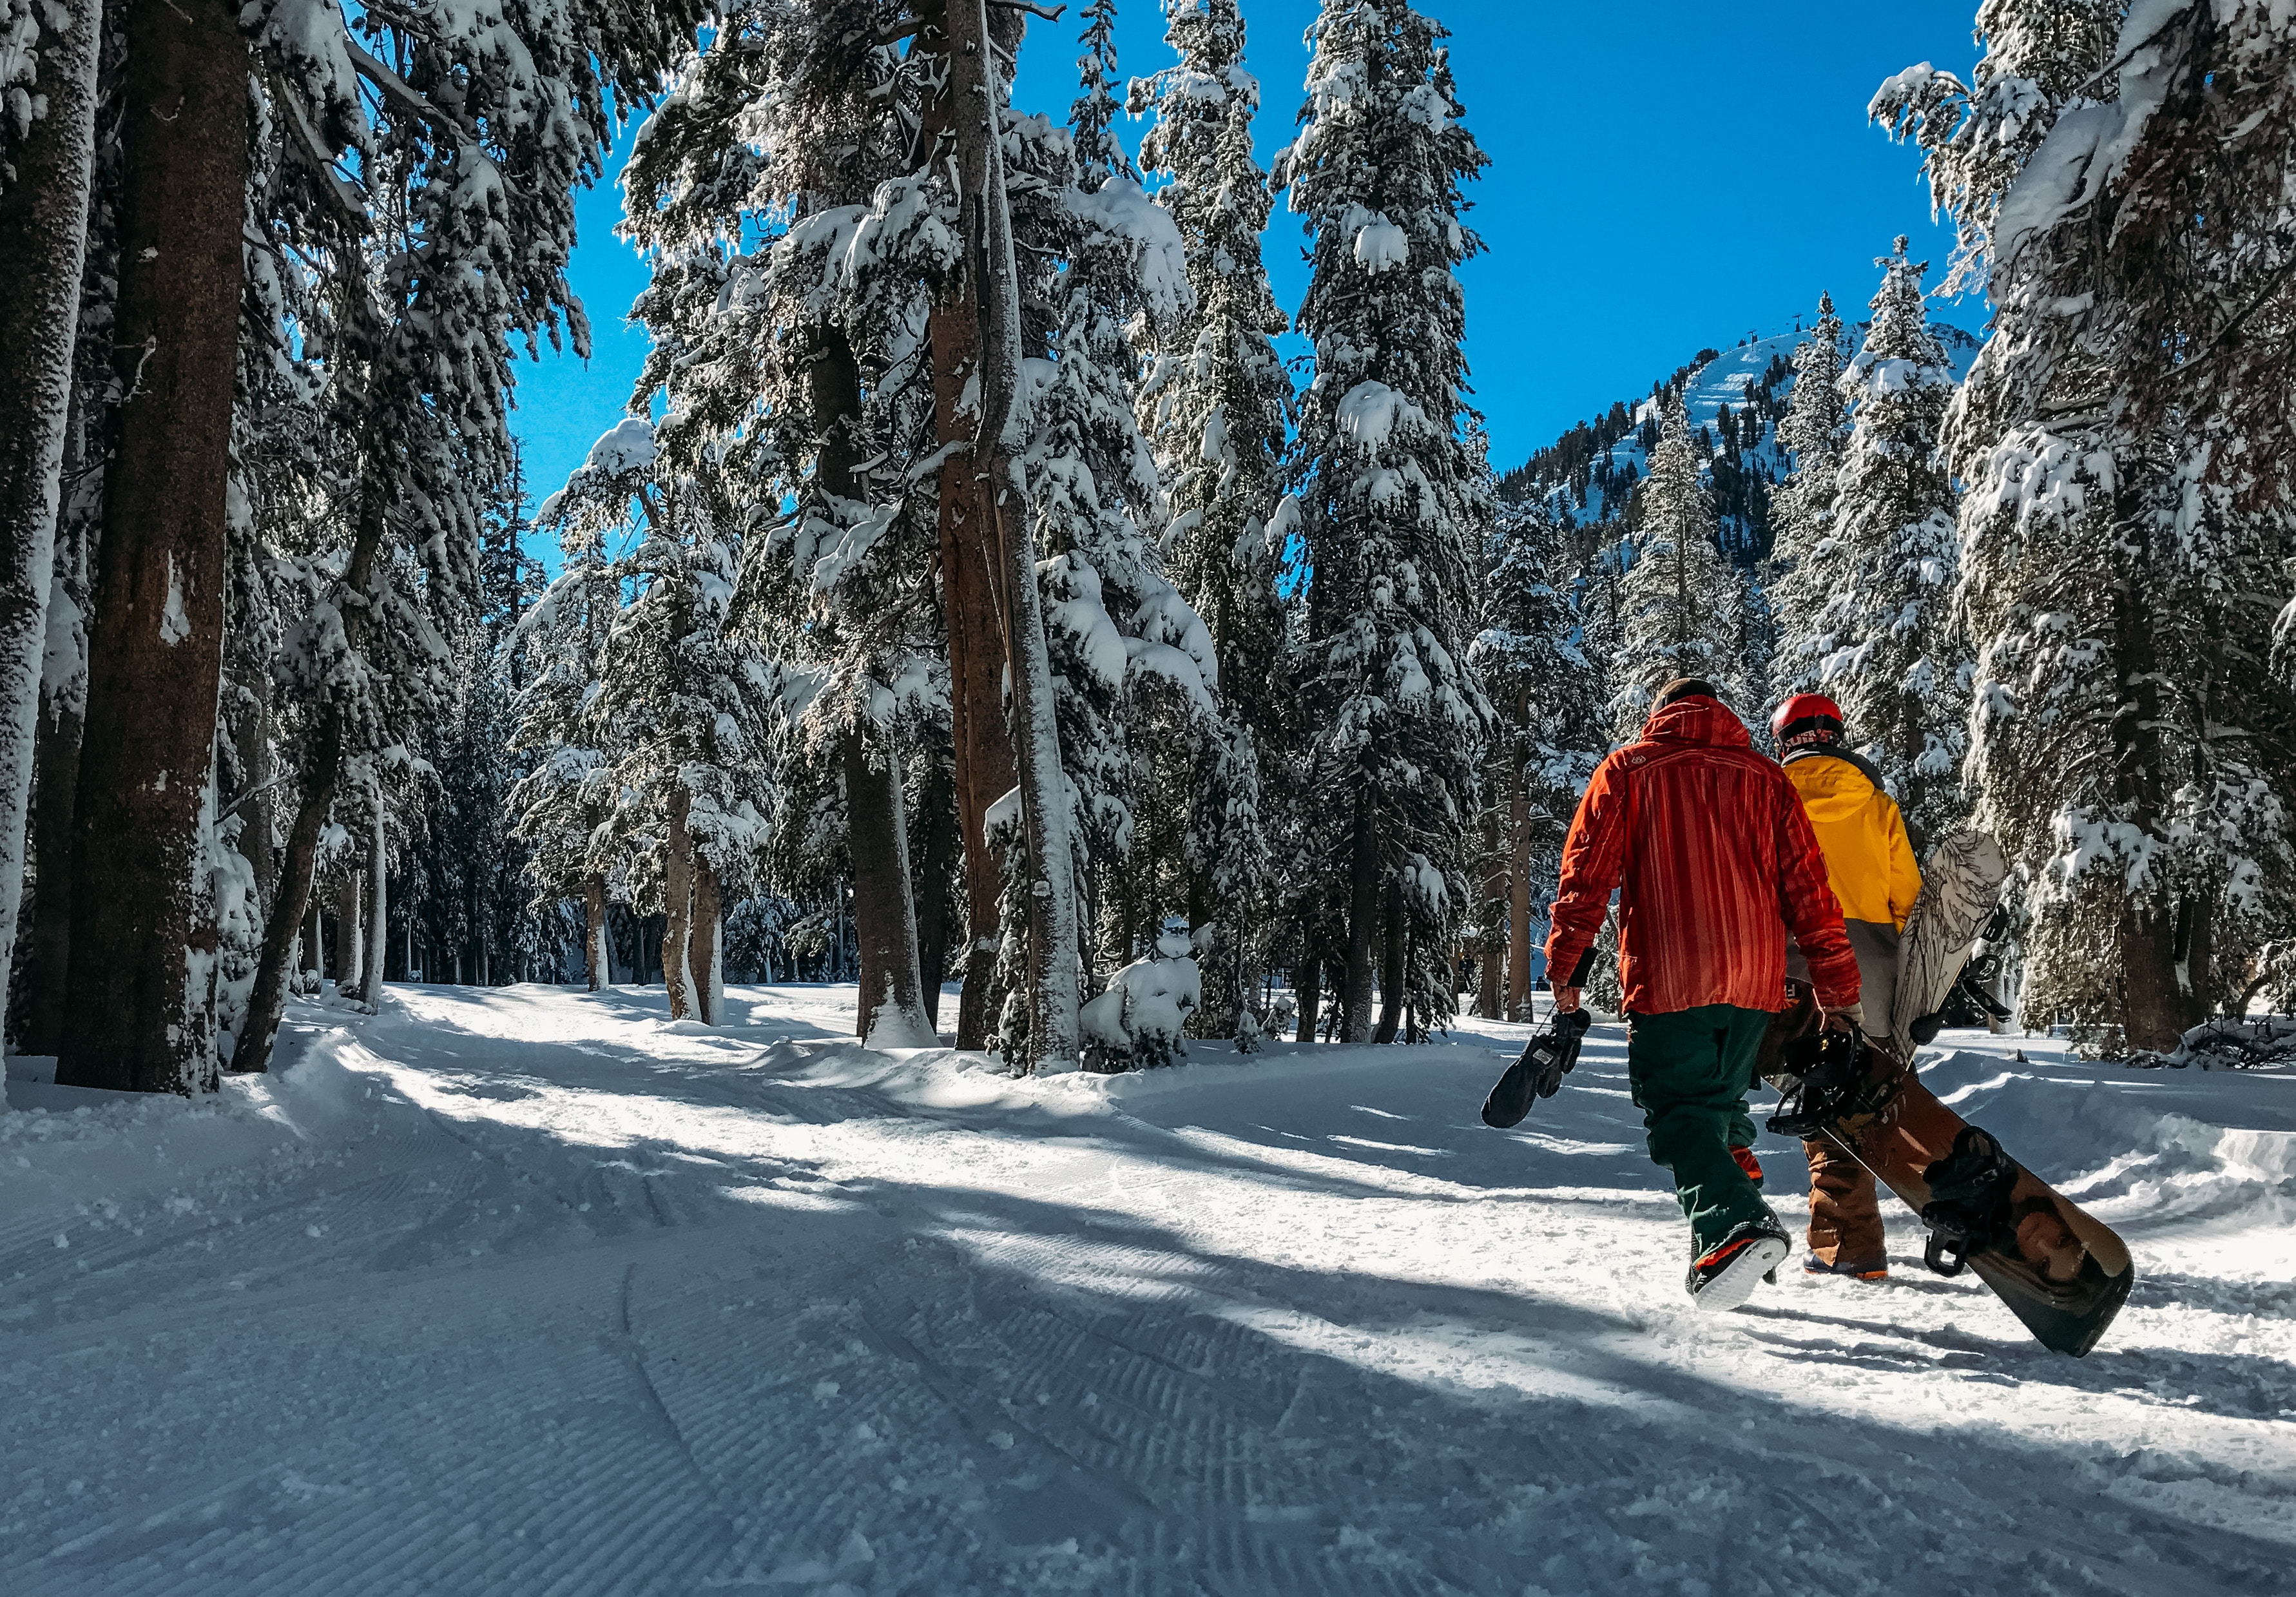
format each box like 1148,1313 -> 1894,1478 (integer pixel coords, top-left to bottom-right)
1547,696 -> 1857,1016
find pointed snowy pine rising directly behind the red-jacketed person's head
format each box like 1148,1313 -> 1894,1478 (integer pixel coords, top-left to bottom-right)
1610,386 -> 1757,742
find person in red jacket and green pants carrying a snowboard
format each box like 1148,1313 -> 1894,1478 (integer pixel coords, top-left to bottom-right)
1547,678 -> 1857,1310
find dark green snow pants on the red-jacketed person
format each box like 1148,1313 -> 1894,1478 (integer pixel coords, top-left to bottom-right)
1626,1004 -> 1777,1257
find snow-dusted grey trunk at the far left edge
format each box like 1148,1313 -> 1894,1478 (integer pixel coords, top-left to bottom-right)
0,0 -> 103,1038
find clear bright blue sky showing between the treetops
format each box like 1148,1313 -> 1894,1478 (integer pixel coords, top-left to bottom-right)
512,0 -> 1983,519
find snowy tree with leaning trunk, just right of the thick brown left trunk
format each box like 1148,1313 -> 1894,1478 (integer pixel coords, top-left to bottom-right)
215,0 -> 698,1089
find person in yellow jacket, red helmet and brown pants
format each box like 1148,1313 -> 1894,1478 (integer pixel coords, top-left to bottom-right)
1770,694 -> 1922,1280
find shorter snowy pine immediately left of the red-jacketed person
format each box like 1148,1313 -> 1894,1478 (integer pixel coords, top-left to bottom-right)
1469,505 -> 1610,1020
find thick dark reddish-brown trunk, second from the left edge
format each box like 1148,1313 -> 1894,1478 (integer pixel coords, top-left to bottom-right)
57,0 -> 249,1092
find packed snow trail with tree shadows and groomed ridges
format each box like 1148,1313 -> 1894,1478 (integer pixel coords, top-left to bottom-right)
0,988 -> 2296,1597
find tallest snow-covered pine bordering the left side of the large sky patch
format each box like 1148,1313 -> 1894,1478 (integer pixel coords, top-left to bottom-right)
1274,0 -> 1492,1041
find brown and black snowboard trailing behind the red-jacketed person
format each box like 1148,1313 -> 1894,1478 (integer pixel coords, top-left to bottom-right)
1759,1002 -> 2136,1358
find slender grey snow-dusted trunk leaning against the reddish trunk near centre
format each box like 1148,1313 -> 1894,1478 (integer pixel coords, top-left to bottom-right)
949,0 -> 1081,1069
